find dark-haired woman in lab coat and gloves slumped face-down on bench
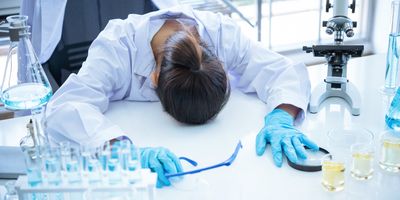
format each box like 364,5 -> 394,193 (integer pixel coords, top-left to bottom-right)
46,7 -> 318,187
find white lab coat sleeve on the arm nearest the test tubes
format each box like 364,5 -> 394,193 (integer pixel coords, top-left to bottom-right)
46,20 -> 136,147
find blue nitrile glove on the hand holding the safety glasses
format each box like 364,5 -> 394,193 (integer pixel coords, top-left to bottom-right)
140,147 -> 182,188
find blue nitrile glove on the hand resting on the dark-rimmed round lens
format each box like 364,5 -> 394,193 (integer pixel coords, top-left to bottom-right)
256,108 -> 319,167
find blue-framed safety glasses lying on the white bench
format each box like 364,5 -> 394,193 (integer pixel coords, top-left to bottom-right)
165,141 -> 242,178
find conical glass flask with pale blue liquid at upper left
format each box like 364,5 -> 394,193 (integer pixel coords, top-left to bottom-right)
0,15 -> 52,145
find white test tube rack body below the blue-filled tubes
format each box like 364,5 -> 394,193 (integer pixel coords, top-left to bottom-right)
15,169 -> 157,200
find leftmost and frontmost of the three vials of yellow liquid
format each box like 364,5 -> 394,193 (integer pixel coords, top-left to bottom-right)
322,154 -> 345,191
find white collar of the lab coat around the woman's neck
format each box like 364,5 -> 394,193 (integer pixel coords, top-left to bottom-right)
133,6 -> 198,77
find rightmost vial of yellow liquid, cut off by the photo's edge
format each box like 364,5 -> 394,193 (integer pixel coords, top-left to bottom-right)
379,131 -> 400,172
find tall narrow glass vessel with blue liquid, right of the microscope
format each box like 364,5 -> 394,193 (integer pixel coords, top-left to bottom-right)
384,0 -> 400,93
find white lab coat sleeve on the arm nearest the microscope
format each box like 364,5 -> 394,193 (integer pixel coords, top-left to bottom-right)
220,17 -> 310,124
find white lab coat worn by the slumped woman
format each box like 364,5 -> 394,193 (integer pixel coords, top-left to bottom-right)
46,7 -> 310,147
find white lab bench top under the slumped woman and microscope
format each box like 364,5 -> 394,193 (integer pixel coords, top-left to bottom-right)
0,55 -> 400,200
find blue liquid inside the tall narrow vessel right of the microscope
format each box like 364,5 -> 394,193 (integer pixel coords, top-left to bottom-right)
385,34 -> 400,89
